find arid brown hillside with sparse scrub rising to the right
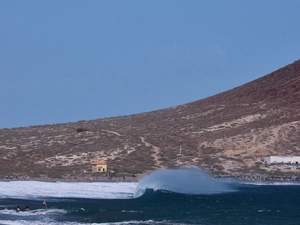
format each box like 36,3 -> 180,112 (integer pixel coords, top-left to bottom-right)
0,60 -> 300,178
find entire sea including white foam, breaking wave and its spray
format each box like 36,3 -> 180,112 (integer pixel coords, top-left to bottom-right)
0,168 -> 300,225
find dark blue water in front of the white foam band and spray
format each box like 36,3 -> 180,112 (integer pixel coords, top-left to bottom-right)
0,169 -> 300,225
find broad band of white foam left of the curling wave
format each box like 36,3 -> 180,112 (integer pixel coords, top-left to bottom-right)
0,181 -> 137,199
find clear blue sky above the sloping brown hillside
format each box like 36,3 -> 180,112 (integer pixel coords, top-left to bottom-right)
0,0 -> 300,128
